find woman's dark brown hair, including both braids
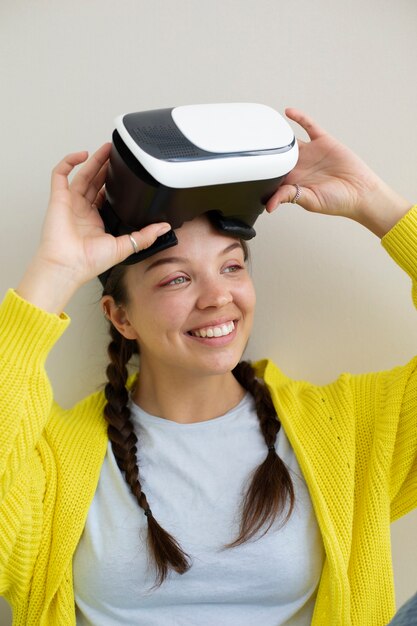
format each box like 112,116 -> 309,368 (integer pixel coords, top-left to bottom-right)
103,246 -> 294,586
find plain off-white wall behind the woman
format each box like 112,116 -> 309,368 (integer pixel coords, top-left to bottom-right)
0,0 -> 417,626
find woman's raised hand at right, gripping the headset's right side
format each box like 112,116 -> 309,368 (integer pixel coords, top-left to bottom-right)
266,109 -> 412,237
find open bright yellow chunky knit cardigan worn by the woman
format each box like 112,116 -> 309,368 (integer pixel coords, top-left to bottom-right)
0,206 -> 417,626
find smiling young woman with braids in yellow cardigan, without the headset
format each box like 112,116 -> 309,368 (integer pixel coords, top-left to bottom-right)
0,109 -> 417,626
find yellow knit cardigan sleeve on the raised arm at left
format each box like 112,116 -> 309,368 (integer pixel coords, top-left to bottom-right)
0,290 -> 69,596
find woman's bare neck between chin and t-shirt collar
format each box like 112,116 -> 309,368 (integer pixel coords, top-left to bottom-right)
132,367 -> 245,424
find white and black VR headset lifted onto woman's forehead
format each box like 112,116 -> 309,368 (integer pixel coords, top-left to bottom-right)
99,103 -> 298,284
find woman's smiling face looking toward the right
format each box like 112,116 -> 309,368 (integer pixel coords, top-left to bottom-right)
112,217 -> 255,376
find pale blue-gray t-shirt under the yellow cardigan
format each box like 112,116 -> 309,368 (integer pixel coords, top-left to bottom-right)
73,394 -> 324,626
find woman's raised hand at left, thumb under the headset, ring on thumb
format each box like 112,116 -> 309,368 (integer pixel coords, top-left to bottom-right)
17,143 -> 170,313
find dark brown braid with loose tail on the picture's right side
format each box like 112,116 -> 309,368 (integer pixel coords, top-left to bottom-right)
226,361 -> 294,548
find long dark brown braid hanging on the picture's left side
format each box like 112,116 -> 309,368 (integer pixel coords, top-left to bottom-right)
104,324 -> 190,586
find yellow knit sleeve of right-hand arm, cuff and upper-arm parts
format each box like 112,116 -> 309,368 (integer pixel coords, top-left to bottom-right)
351,206 -> 417,520
